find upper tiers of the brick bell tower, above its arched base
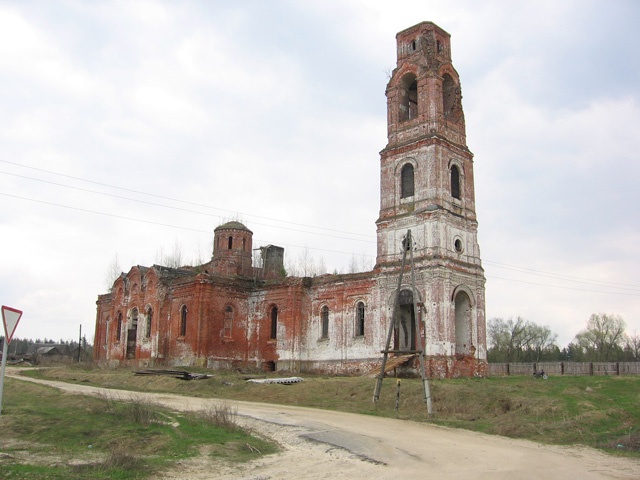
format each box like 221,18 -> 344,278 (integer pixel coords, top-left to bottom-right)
376,22 -> 479,267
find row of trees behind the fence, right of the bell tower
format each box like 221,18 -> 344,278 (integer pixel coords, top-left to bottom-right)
487,313 -> 640,363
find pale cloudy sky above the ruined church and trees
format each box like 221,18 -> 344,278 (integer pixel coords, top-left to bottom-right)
0,0 -> 640,346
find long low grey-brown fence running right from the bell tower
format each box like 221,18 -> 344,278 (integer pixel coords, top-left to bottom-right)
488,362 -> 640,377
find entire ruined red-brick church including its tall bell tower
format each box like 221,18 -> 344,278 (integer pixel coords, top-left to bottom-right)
94,22 -> 486,377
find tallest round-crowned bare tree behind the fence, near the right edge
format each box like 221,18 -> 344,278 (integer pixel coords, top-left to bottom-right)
576,313 -> 626,361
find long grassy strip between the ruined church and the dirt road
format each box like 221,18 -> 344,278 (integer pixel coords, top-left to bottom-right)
17,367 -> 640,456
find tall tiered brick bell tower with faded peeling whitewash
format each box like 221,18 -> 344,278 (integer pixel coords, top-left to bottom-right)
376,22 -> 486,368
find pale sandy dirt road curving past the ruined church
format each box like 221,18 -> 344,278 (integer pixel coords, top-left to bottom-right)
8,374 -> 640,480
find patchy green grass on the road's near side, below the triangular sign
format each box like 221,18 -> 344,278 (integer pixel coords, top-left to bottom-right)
0,378 -> 276,480
